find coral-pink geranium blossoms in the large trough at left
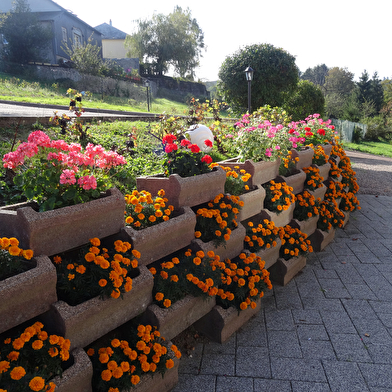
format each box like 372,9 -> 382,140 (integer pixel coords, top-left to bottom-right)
3,131 -> 126,190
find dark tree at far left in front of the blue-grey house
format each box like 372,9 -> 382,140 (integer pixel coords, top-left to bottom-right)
0,0 -> 52,64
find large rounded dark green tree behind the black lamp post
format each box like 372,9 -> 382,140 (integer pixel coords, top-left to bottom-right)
218,44 -> 299,111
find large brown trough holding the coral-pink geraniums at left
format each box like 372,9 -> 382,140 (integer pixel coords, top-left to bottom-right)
0,188 -> 125,256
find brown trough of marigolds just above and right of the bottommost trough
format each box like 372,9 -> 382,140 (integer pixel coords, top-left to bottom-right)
142,295 -> 216,340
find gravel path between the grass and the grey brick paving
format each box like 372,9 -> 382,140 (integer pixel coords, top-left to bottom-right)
346,151 -> 392,196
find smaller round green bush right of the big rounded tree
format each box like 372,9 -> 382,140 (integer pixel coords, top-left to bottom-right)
283,80 -> 325,121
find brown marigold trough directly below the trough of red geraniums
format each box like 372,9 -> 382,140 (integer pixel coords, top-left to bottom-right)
121,207 -> 196,265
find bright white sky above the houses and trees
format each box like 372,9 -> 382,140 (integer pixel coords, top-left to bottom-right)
55,0 -> 392,81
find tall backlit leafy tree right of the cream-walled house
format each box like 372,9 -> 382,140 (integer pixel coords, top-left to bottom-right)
125,6 -> 204,78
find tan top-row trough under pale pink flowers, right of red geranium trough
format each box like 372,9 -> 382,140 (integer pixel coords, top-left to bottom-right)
219,158 -> 280,187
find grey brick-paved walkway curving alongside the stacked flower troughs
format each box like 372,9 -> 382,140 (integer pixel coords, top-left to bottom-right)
172,195 -> 392,392
